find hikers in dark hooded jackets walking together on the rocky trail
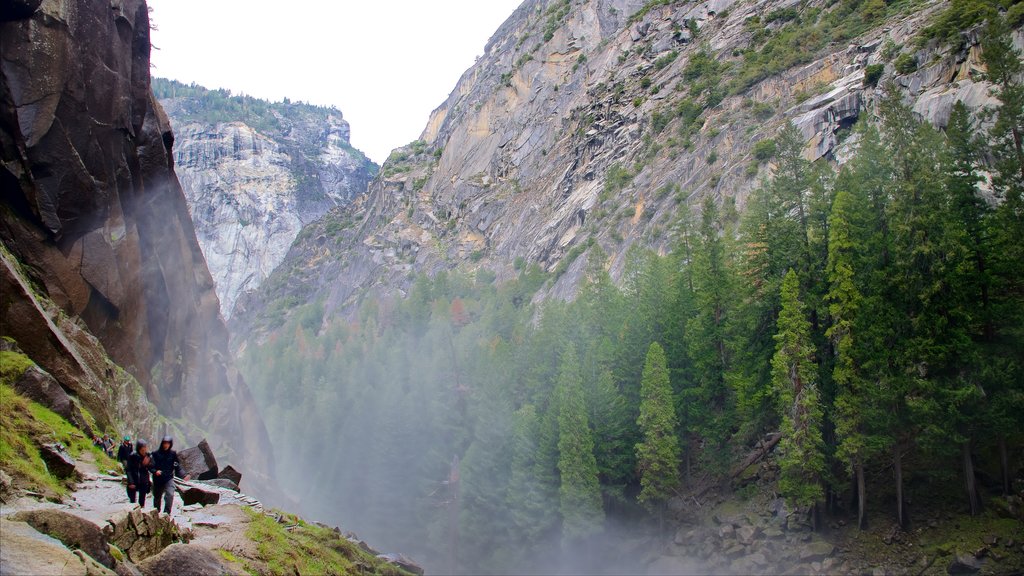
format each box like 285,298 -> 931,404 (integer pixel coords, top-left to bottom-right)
118,436 -> 189,516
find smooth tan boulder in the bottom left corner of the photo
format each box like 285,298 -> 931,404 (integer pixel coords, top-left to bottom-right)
0,518 -> 86,576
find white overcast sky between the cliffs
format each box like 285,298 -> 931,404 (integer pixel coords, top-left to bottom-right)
148,0 -> 522,163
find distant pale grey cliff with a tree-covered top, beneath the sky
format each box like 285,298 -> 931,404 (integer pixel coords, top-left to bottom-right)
154,80 -> 377,318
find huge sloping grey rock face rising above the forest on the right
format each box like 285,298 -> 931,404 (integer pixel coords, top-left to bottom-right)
231,0 -> 1022,339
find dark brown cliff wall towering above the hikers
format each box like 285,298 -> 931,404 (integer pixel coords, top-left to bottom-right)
0,0 -> 272,494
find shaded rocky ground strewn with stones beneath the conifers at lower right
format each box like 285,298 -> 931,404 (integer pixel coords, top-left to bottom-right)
648,461 -> 1024,576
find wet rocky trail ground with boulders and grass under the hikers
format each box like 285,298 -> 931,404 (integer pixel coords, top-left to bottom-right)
0,454 -> 418,576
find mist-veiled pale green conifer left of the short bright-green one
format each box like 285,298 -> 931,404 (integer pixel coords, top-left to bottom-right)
555,342 -> 604,544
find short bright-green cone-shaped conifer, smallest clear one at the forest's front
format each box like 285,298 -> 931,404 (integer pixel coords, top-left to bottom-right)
636,342 -> 679,507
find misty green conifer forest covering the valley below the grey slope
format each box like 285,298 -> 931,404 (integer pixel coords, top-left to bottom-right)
242,15 -> 1024,572
